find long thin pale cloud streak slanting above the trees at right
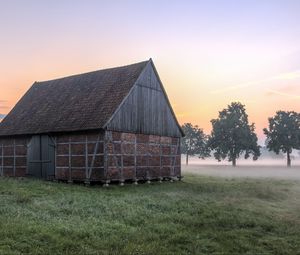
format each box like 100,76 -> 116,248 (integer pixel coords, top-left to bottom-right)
210,70 -> 300,94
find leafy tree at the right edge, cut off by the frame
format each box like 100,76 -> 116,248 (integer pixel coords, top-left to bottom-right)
264,111 -> 300,167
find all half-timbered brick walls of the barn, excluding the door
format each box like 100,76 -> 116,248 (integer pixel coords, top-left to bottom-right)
0,131 -> 181,182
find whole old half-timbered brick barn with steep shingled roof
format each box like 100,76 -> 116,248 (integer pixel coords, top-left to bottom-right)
0,59 -> 183,184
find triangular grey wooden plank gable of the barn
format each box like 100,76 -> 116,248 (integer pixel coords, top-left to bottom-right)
107,62 -> 181,137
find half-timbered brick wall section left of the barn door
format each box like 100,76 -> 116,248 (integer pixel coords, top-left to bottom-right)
0,138 -> 28,177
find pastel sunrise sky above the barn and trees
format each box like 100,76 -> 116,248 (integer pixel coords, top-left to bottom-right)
0,0 -> 300,142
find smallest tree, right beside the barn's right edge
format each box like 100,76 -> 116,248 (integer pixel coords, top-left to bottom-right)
181,123 -> 210,165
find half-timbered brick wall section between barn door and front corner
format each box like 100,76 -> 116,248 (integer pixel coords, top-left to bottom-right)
55,131 -> 104,181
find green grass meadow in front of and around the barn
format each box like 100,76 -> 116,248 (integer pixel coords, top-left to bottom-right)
0,175 -> 300,255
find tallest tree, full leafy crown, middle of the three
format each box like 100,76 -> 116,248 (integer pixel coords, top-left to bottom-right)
208,102 -> 260,166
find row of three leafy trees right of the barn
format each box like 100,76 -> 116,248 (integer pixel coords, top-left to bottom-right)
181,102 -> 300,166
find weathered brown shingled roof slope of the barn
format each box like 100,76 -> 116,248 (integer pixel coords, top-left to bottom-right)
0,60 -> 151,136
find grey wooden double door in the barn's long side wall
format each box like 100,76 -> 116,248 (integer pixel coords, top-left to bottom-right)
27,135 -> 55,180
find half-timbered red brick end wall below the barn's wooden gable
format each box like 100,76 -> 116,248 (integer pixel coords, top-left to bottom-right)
106,131 -> 181,180
